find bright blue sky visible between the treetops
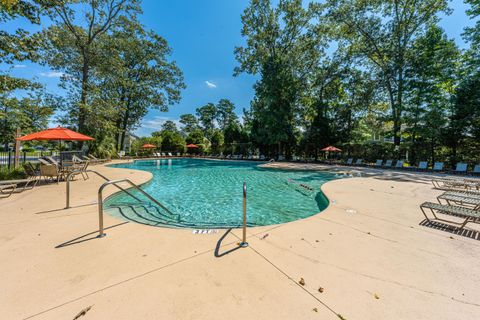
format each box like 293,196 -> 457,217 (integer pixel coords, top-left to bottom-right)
2,0 -> 472,135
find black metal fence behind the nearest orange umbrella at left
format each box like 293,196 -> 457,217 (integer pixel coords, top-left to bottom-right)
0,151 -> 85,169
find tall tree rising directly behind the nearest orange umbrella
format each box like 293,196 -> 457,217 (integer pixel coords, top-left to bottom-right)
39,0 -> 140,132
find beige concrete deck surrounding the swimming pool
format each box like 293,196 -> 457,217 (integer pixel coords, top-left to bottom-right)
0,163 -> 480,320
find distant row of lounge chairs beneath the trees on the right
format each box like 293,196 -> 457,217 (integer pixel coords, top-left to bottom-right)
345,158 -> 480,174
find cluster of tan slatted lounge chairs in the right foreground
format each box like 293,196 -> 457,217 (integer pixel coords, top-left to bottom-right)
420,178 -> 480,229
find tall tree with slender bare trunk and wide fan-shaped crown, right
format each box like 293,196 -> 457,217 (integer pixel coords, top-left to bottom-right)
320,0 -> 449,146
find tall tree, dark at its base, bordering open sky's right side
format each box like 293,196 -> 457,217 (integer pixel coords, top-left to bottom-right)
235,0 -> 323,158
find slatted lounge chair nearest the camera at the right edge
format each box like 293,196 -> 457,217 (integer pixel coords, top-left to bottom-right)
420,202 -> 480,229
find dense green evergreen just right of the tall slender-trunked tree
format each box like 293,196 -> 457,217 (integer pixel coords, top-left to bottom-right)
405,25 -> 460,162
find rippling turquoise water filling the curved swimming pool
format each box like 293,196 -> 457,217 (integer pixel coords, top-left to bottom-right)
105,159 -> 338,228
